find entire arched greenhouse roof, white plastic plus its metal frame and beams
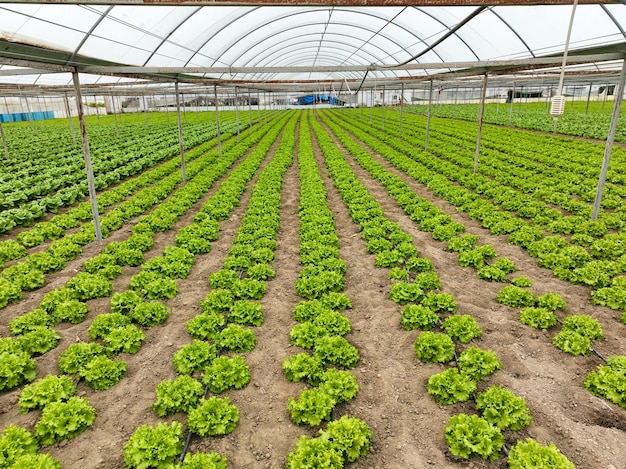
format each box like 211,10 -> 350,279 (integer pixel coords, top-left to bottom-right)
0,0 -> 626,89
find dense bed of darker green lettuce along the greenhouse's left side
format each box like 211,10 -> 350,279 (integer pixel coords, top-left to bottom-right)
0,114 -> 243,234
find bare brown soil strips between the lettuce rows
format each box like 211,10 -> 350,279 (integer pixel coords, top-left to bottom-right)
0,113 -> 626,469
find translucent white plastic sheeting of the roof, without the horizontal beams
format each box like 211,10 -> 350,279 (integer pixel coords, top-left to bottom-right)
0,3 -> 626,85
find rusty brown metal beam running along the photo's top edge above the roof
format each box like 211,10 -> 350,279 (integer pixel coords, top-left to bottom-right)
0,0 -> 615,7
